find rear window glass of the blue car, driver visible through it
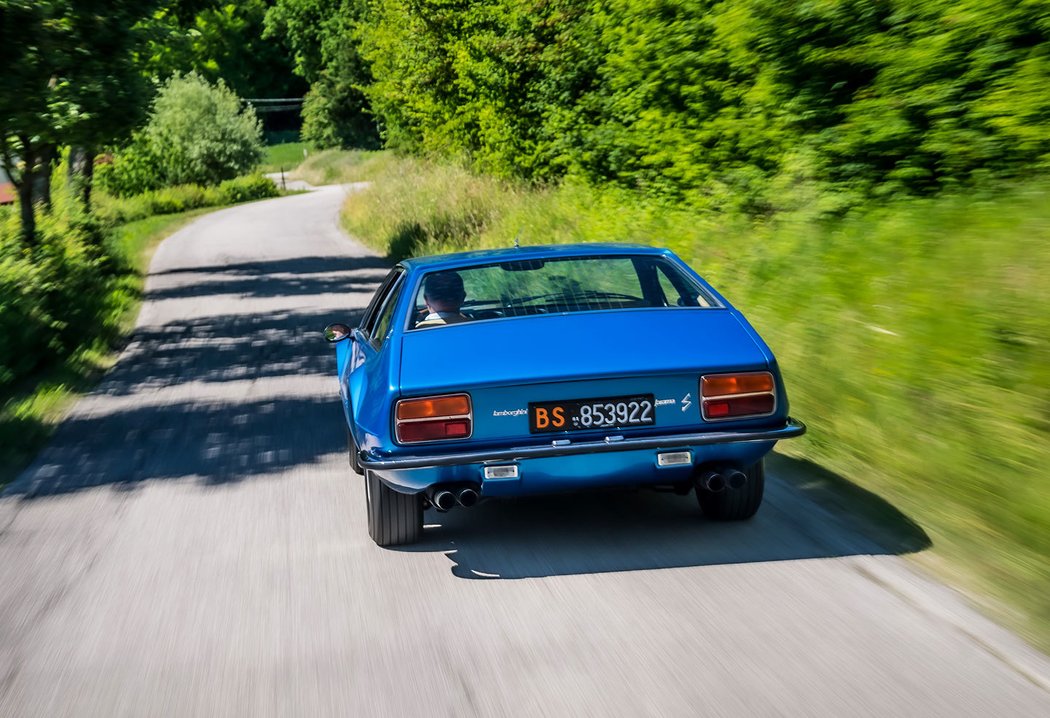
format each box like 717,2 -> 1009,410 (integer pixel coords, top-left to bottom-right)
410,255 -> 717,329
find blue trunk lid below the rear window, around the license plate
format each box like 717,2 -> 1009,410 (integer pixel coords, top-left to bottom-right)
401,309 -> 768,441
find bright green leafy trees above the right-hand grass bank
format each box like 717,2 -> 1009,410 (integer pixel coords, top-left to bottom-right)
340,0 -> 1050,201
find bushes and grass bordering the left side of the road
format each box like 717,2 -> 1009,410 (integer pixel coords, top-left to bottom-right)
0,75 -> 278,485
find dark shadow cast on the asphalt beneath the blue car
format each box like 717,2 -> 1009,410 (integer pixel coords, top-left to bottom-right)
397,457 -> 931,579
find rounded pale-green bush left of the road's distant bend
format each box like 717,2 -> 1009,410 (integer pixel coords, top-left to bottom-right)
98,73 -> 263,196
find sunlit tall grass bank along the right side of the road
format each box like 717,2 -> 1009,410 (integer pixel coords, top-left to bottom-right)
336,153 -> 1050,650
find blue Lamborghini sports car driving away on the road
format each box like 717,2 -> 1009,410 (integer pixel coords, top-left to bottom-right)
324,245 -> 805,546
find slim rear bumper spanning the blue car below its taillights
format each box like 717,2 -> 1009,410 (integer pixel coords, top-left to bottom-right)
359,418 -> 805,471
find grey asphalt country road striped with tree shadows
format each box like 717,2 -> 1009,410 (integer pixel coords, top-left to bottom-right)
0,187 -> 1050,718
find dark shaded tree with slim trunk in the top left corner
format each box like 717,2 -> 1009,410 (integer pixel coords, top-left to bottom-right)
0,0 -> 160,246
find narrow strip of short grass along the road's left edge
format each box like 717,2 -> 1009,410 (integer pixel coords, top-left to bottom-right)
0,209 -> 210,489
